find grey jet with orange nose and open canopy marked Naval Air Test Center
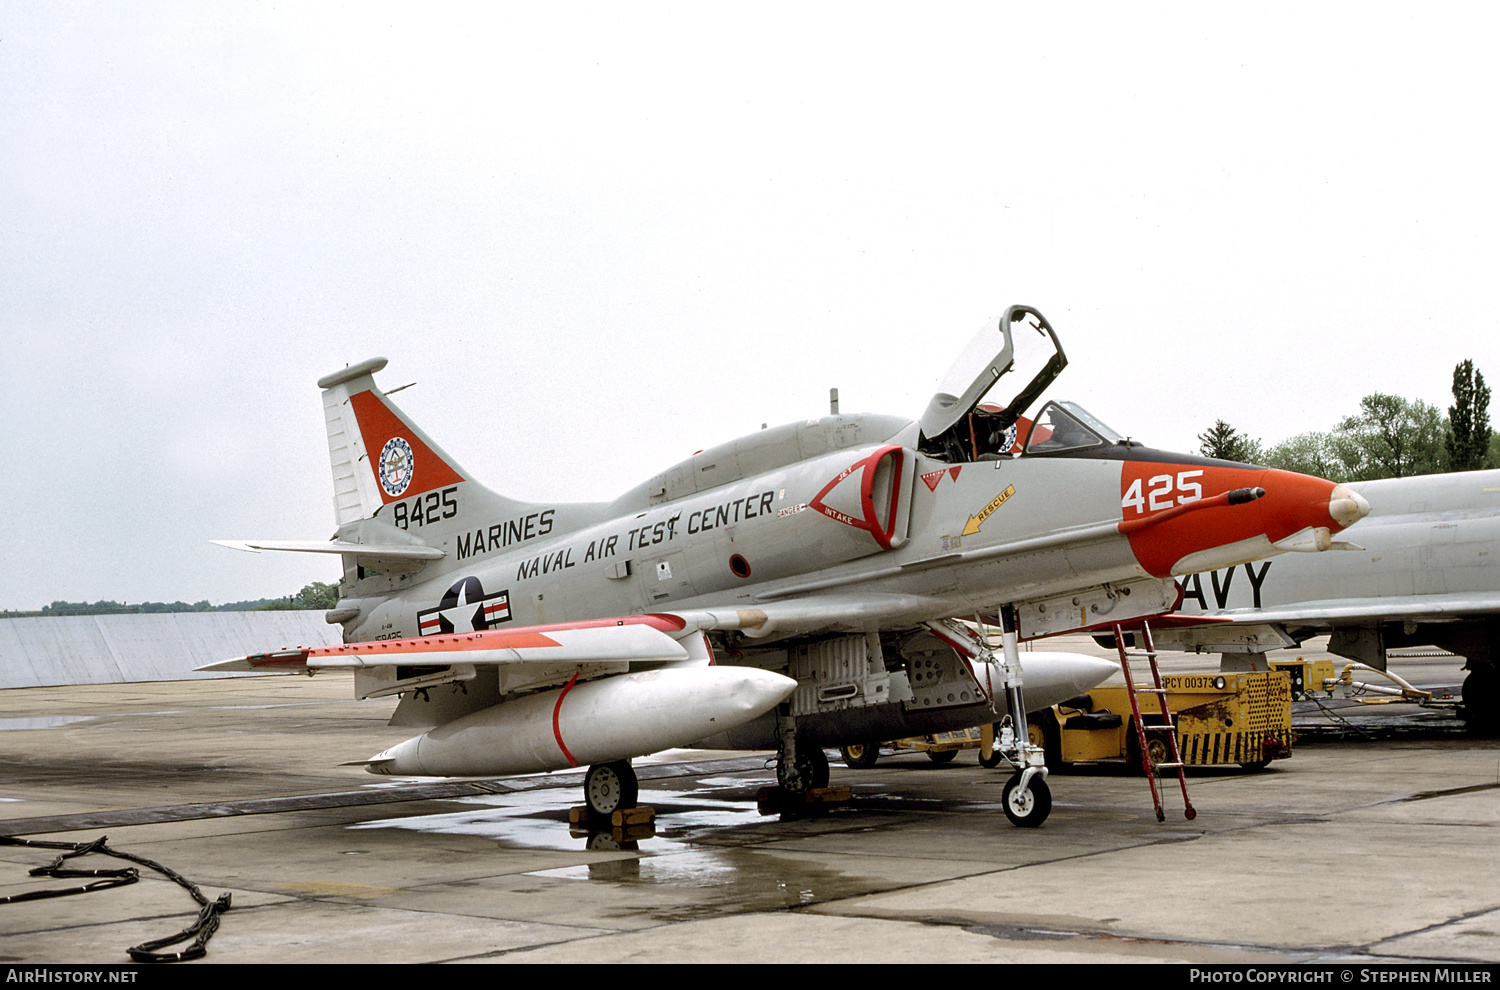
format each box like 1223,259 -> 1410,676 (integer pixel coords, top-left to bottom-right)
203,306 -> 1368,825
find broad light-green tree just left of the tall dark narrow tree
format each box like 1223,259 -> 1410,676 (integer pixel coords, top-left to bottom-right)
1332,392 -> 1448,482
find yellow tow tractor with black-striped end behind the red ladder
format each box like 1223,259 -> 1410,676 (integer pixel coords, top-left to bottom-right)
1028,671 -> 1295,770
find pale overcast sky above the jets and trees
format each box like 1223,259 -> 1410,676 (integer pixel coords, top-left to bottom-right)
0,0 -> 1500,609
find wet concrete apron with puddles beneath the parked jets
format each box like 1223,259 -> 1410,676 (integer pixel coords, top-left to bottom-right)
0,641 -> 1500,966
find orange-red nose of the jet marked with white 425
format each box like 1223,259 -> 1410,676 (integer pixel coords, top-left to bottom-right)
1121,462 -> 1370,578
